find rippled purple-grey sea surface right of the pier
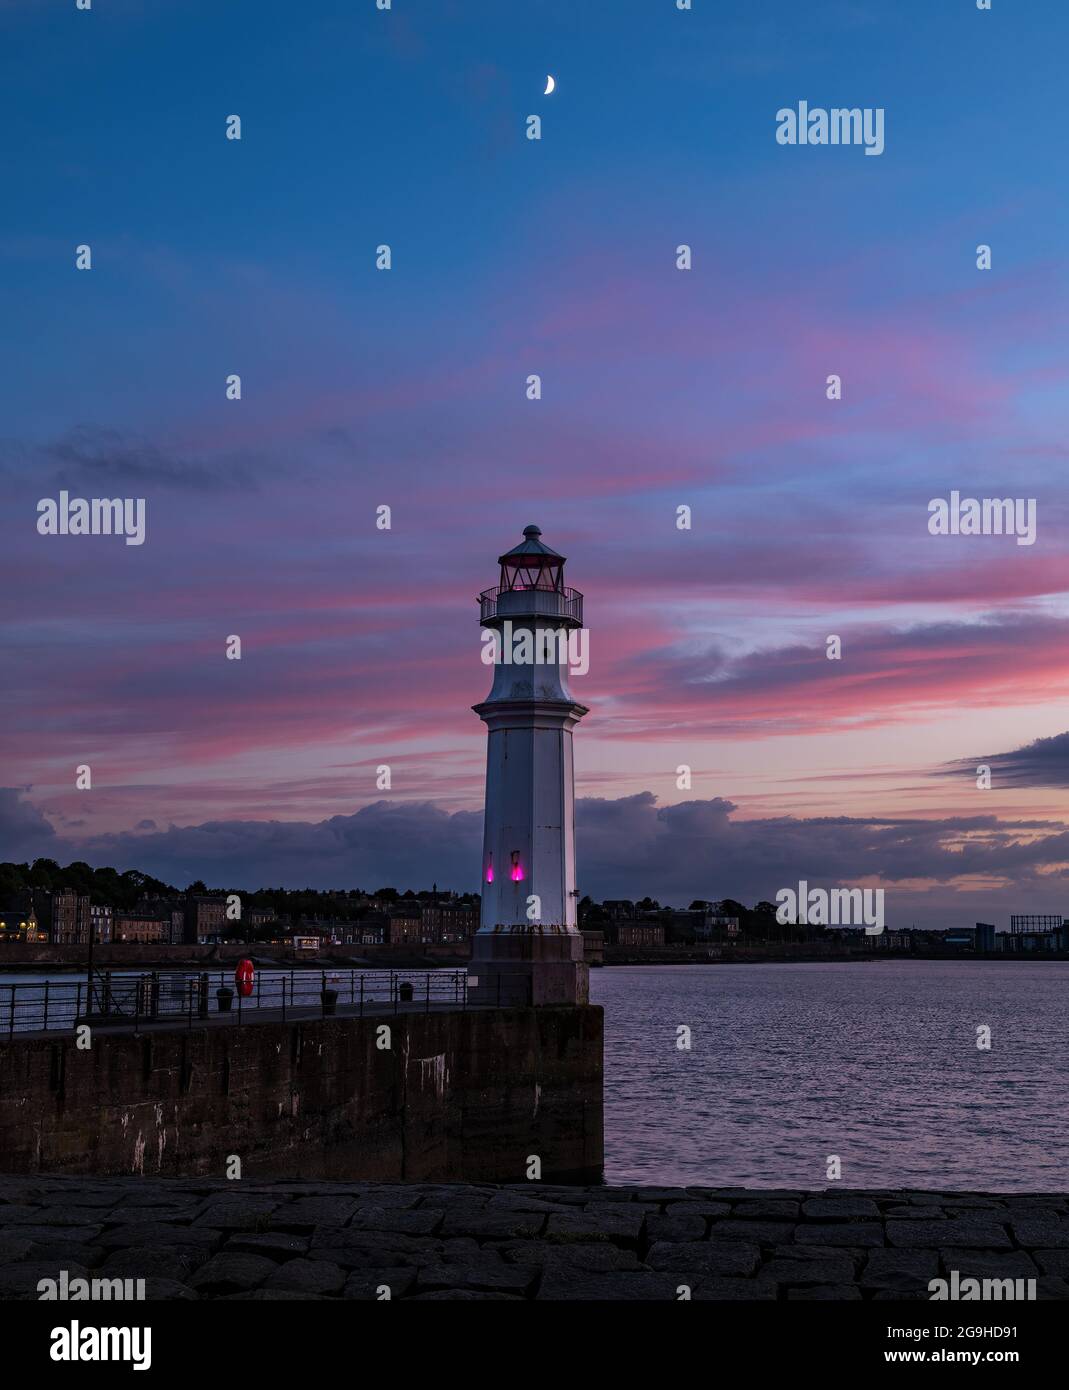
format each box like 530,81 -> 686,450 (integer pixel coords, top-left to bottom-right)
591,960 -> 1069,1191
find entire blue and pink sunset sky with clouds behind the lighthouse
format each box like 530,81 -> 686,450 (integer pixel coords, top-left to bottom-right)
0,0 -> 1069,927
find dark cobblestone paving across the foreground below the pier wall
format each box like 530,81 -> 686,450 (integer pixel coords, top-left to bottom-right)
0,1177 -> 1069,1300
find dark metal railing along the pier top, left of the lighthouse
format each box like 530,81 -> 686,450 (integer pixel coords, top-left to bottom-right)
0,967 -> 530,1038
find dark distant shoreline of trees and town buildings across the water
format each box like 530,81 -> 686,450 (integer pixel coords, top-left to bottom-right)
0,862 -> 1069,962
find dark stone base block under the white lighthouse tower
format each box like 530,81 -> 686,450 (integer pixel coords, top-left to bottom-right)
467,923 -> 591,1008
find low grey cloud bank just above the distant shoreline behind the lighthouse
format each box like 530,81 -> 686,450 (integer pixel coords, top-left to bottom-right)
0,788 -> 1069,926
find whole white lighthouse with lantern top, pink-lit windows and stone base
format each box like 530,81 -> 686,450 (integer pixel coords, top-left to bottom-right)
471,525 -> 589,1004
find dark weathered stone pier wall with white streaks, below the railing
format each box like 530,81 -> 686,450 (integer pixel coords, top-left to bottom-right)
0,1008 -> 602,1182
